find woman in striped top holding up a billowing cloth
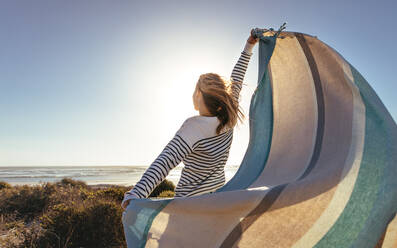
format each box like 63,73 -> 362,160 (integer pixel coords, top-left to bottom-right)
121,30 -> 259,208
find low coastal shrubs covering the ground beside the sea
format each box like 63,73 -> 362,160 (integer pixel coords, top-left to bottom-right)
0,178 -> 175,248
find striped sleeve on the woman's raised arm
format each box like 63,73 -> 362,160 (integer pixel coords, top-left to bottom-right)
231,41 -> 255,102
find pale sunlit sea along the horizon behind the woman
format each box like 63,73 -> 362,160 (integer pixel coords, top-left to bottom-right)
0,165 -> 239,186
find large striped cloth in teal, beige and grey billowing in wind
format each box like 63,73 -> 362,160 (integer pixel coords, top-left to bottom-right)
122,25 -> 397,248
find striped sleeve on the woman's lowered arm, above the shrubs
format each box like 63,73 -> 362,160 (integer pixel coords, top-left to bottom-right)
124,118 -> 197,200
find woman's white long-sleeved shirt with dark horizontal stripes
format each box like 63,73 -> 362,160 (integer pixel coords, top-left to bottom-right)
123,42 -> 254,202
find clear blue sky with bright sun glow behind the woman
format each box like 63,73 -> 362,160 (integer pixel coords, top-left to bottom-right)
0,0 -> 397,166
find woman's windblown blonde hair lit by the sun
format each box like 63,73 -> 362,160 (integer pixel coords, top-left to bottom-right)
196,73 -> 245,134
